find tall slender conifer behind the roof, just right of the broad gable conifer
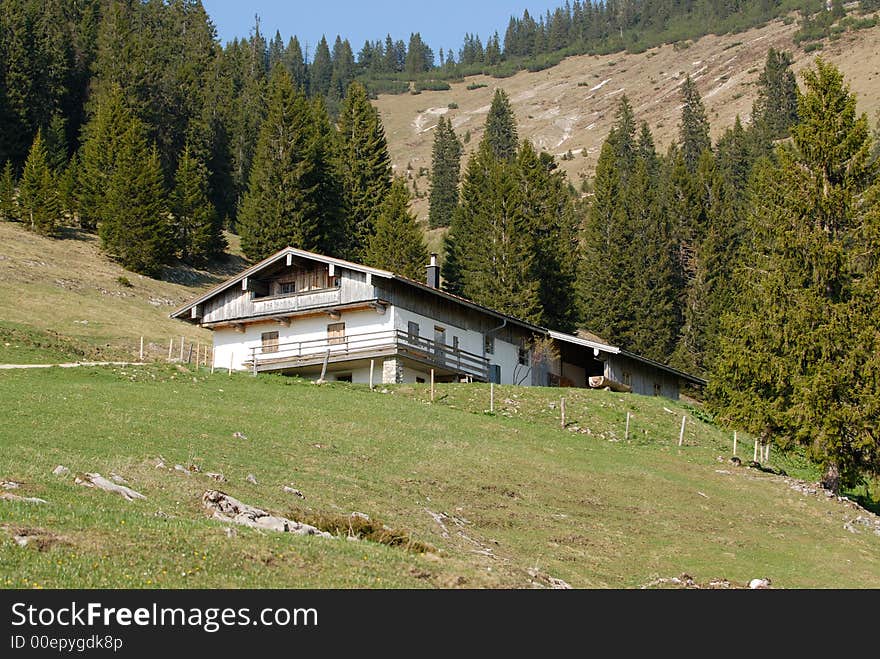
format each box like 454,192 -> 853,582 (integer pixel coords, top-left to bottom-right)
338,82 -> 391,261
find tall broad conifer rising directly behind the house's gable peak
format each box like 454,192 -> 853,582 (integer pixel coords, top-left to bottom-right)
238,67 -> 332,260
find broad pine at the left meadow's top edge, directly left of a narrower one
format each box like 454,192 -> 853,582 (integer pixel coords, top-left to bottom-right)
98,119 -> 174,277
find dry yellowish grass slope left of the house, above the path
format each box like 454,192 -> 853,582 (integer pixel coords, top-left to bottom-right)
0,222 -> 244,363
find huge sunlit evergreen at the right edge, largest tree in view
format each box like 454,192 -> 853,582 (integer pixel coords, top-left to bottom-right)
709,60 -> 880,491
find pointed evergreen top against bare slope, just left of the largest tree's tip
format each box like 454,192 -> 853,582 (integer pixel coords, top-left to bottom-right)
752,48 -> 798,141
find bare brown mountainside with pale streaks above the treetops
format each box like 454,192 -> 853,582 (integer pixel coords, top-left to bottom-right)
376,21 -> 880,223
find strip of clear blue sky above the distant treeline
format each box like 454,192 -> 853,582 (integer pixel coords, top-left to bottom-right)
202,0 -> 565,55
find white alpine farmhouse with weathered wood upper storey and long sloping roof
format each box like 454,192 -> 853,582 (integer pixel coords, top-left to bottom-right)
171,247 -> 705,398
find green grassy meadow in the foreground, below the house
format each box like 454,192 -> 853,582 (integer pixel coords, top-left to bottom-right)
0,366 -> 880,588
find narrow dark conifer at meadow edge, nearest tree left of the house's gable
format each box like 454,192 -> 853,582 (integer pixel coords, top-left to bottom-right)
170,145 -> 226,264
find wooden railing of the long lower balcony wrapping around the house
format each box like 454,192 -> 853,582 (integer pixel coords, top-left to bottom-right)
249,330 -> 489,380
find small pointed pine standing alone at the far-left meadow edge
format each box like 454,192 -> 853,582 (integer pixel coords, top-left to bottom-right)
18,130 -> 61,236
